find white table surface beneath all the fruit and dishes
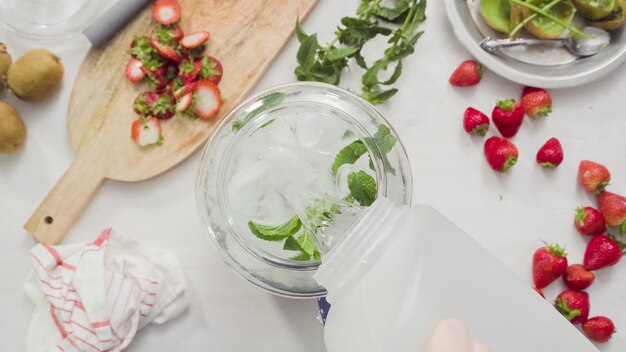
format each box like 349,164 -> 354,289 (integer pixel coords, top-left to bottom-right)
0,0 -> 626,352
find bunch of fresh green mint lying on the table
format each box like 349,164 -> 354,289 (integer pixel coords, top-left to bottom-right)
295,0 -> 426,104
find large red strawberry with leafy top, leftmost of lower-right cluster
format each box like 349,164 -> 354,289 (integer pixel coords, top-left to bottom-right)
533,244 -> 567,289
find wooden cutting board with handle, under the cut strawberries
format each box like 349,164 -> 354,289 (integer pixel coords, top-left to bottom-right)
24,0 -> 317,244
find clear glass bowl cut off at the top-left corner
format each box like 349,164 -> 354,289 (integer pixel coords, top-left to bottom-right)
0,0 -> 102,39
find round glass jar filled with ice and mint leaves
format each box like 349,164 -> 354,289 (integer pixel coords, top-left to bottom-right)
196,83 -> 412,298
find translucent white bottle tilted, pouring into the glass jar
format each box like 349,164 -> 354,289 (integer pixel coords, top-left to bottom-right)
315,199 -> 598,352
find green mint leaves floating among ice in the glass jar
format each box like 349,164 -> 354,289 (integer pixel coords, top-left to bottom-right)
248,125 -> 396,261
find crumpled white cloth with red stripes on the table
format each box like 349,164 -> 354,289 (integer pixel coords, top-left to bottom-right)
24,229 -> 189,352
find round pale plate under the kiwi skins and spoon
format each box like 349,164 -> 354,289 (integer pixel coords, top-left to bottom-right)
444,0 -> 626,88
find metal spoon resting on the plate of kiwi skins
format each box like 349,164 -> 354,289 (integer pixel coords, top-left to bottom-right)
480,27 -> 611,56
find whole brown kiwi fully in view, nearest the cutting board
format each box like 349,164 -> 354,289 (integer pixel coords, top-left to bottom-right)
7,49 -> 63,101
